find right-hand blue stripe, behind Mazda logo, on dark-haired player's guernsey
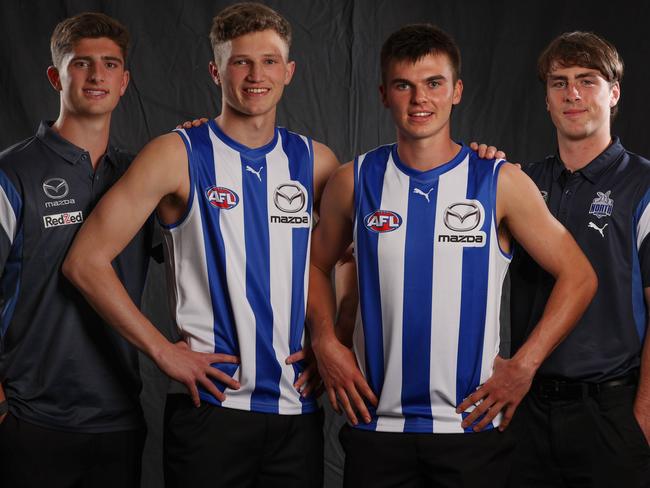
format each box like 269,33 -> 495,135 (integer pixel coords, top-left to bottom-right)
456,152 -> 496,432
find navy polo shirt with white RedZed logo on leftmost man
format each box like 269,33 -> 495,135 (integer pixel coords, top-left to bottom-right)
0,122 -> 152,433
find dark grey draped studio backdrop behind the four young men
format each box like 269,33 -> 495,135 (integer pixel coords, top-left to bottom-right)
0,0 -> 650,488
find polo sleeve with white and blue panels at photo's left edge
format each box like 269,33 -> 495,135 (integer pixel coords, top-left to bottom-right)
0,170 -> 23,351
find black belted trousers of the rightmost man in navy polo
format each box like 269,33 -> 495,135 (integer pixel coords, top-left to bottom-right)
510,385 -> 650,488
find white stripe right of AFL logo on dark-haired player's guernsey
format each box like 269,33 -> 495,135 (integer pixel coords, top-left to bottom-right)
372,155 -> 409,431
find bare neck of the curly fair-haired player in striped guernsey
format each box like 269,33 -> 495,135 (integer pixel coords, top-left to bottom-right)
215,107 -> 275,148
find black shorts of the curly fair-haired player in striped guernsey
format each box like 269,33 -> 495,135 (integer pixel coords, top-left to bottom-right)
163,394 -> 323,488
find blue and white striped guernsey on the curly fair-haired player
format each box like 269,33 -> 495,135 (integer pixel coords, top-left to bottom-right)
163,120 -> 316,414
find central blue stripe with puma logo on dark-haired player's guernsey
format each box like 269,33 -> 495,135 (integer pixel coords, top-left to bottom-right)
402,178 -> 438,432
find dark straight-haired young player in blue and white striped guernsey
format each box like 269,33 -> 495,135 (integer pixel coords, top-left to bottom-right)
308,24 -> 596,488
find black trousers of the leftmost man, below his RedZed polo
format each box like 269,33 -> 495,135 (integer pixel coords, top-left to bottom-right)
0,414 -> 145,488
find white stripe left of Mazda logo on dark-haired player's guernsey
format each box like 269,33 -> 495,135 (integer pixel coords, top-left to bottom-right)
430,157 -> 469,433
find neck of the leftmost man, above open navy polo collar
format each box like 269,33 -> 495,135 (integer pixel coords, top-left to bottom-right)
52,109 -> 111,168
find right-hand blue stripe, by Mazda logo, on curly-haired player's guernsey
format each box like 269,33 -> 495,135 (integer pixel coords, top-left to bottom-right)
280,129 -> 317,413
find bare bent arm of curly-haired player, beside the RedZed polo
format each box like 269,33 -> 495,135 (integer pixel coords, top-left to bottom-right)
63,134 -> 239,405
